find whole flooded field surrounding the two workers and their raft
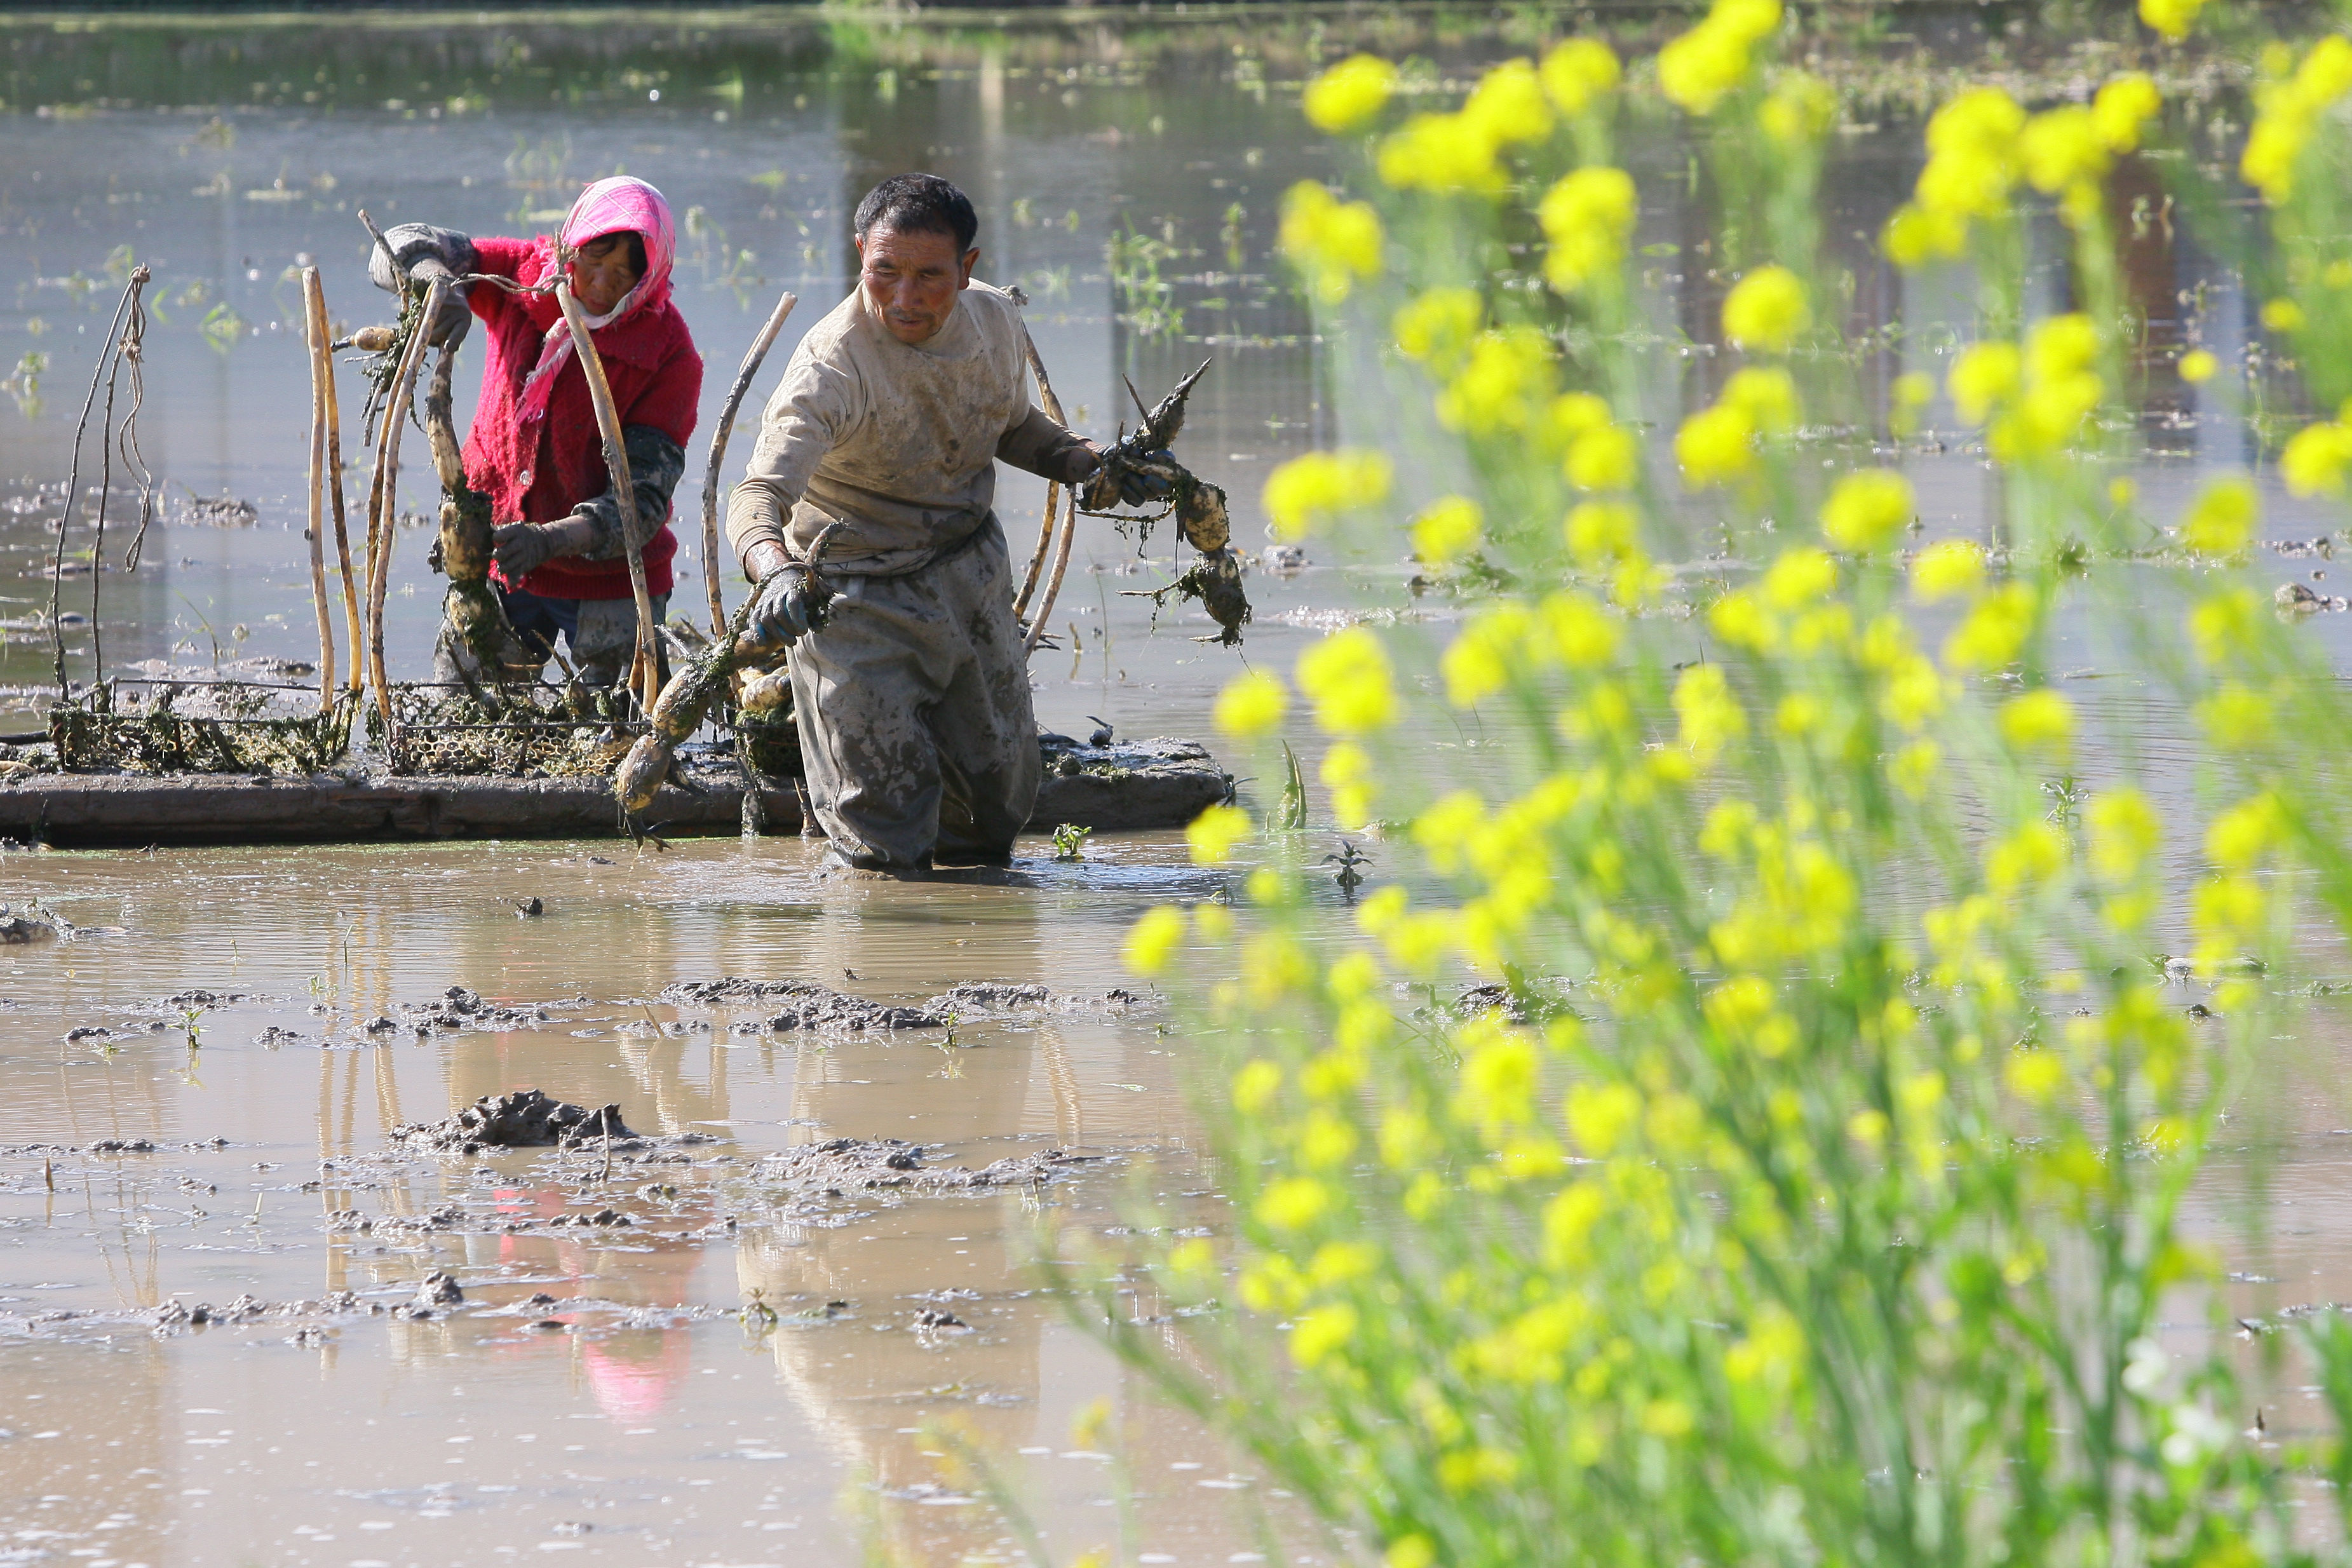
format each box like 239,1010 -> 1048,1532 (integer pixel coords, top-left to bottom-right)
13,7 -> 2352,1568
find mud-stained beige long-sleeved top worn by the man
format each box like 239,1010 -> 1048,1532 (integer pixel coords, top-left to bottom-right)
727,282 -> 1092,576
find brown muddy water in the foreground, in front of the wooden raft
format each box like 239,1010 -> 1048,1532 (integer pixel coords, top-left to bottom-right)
0,839 -> 1288,1564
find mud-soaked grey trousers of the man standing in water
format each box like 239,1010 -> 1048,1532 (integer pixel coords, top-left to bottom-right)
793,513 -> 1044,870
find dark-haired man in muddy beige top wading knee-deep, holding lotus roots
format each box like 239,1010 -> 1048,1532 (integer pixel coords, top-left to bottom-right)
727,174 -> 1148,874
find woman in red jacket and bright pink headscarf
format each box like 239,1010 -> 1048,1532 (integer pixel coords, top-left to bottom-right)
367,177 -> 703,686
